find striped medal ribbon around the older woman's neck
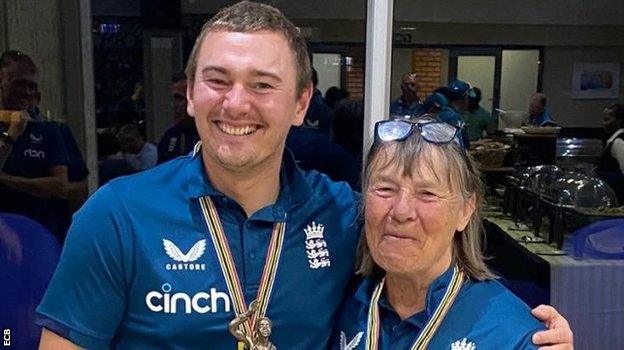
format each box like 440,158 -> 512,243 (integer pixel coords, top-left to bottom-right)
365,265 -> 464,350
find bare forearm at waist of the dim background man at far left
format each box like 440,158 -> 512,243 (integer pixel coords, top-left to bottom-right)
0,165 -> 68,198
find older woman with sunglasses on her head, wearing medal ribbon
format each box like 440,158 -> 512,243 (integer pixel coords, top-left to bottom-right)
333,119 -> 568,350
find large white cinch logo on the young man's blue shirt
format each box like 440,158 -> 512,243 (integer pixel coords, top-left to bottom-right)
145,283 -> 230,314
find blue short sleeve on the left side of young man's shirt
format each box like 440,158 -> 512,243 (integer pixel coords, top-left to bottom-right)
37,185 -> 130,349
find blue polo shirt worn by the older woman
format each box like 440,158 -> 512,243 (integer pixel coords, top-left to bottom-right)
331,269 -> 544,350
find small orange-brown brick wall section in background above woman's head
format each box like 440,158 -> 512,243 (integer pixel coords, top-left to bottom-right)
412,49 -> 443,99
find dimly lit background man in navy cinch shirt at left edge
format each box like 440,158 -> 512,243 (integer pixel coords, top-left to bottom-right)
0,51 -> 69,241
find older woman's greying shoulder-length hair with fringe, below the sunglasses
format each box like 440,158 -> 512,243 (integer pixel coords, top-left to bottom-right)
357,121 -> 495,281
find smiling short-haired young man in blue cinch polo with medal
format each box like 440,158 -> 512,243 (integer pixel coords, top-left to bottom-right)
38,2 -> 571,349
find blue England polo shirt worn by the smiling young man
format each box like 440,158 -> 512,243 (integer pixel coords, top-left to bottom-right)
37,148 -> 359,349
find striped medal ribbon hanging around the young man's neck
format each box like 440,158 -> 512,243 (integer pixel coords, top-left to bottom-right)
199,196 -> 286,335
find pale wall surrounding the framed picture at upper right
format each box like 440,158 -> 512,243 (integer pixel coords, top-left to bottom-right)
543,47 -> 624,127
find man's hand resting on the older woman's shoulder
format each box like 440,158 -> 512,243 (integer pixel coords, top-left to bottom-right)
531,305 -> 574,350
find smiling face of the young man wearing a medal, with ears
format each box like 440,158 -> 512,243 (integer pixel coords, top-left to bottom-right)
187,31 -> 311,171
